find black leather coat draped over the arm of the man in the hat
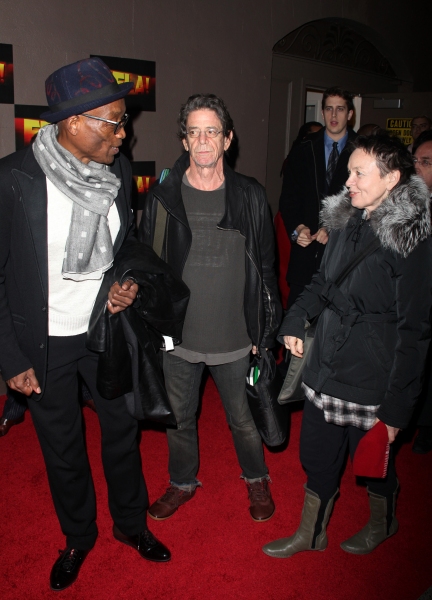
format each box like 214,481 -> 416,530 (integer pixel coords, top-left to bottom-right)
87,240 -> 189,418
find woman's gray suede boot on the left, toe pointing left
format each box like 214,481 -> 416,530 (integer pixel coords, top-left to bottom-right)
262,486 -> 339,558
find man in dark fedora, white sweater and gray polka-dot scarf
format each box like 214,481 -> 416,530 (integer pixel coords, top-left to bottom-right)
0,58 -> 170,590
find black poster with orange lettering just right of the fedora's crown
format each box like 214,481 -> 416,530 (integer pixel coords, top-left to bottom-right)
92,54 -> 156,111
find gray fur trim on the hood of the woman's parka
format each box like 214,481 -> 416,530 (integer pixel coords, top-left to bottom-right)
320,175 -> 432,257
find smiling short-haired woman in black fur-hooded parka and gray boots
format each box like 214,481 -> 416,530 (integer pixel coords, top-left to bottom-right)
263,135 -> 432,558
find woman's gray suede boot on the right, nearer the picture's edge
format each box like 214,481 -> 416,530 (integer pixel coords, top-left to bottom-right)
341,485 -> 399,554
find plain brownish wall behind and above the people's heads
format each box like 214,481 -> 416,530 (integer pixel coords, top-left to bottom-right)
0,0 -> 432,188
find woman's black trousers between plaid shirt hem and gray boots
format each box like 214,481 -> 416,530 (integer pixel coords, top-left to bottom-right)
300,400 -> 397,502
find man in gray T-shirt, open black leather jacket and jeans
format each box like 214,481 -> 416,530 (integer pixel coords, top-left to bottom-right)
140,94 -> 281,522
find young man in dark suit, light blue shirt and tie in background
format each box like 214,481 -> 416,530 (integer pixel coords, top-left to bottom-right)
279,87 -> 356,308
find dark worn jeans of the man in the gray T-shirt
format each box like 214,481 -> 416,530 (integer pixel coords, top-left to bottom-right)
163,352 -> 268,485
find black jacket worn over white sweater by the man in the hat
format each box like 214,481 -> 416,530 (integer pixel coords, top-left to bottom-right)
0,147 -> 133,400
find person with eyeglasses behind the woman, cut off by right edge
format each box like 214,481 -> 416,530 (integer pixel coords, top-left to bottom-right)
412,129 -> 432,454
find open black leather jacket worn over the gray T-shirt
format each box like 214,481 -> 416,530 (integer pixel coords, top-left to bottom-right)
139,153 -> 282,348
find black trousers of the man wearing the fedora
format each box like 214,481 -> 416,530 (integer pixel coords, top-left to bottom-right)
29,334 -> 148,550
